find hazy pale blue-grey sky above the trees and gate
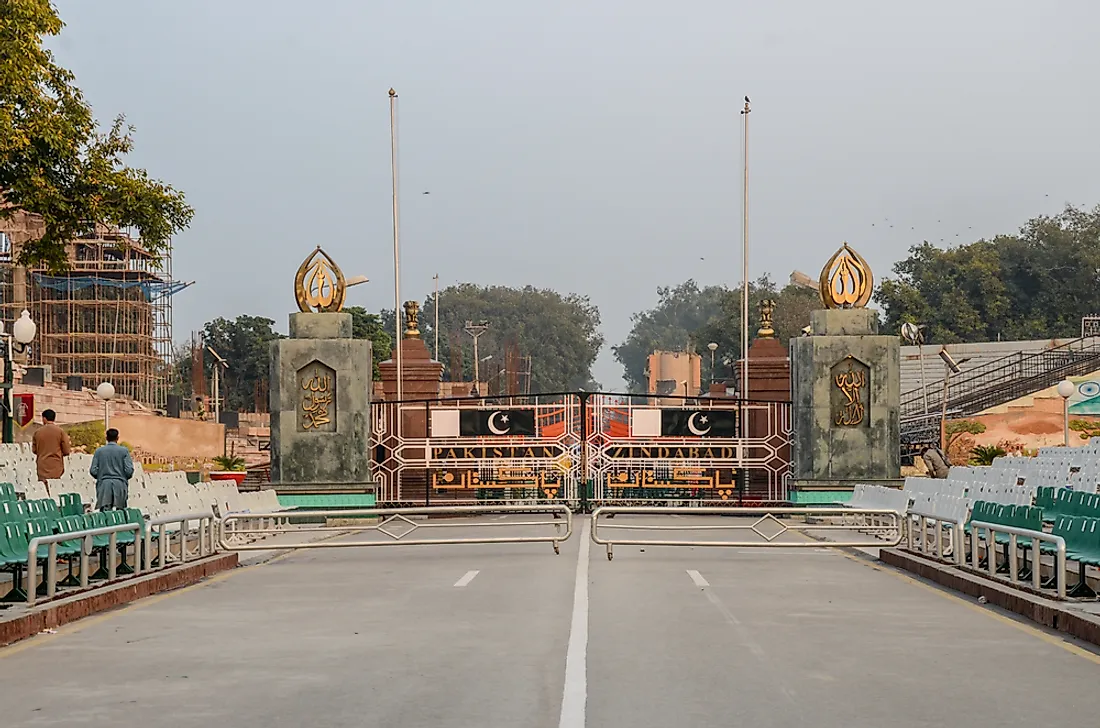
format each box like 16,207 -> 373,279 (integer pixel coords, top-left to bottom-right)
53,0 -> 1100,387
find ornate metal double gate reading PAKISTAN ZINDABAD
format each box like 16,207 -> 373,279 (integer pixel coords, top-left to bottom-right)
371,393 -> 791,510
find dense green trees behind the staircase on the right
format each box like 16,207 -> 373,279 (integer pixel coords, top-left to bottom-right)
876,207 -> 1100,343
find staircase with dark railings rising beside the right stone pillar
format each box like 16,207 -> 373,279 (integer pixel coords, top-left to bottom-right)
901,337 -> 1100,442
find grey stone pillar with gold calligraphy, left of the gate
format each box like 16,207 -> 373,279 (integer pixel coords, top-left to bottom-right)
271,313 -> 373,494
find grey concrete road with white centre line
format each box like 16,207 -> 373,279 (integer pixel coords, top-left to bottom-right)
0,519 -> 1100,728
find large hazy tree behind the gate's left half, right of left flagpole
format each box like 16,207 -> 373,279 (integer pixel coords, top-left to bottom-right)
413,284 -> 604,393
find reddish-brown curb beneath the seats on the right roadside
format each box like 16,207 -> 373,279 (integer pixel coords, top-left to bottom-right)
879,549 -> 1100,646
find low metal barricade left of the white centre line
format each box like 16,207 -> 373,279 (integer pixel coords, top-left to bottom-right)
220,504 -> 573,553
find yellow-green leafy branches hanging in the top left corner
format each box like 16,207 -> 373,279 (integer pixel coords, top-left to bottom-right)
0,0 -> 194,271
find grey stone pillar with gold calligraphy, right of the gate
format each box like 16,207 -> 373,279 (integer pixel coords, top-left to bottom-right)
791,308 -> 901,501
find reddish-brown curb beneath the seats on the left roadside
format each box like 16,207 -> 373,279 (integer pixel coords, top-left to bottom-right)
0,552 -> 238,647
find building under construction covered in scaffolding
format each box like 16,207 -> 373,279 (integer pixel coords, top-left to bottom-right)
0,212 -> 188,408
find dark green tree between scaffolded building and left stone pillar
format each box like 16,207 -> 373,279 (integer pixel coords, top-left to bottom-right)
202,316 -> 283,411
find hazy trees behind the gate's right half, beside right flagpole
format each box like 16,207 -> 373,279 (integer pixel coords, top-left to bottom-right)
612,276 -> 821,391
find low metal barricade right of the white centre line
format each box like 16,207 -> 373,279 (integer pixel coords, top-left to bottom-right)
592,506 -> 902,560
